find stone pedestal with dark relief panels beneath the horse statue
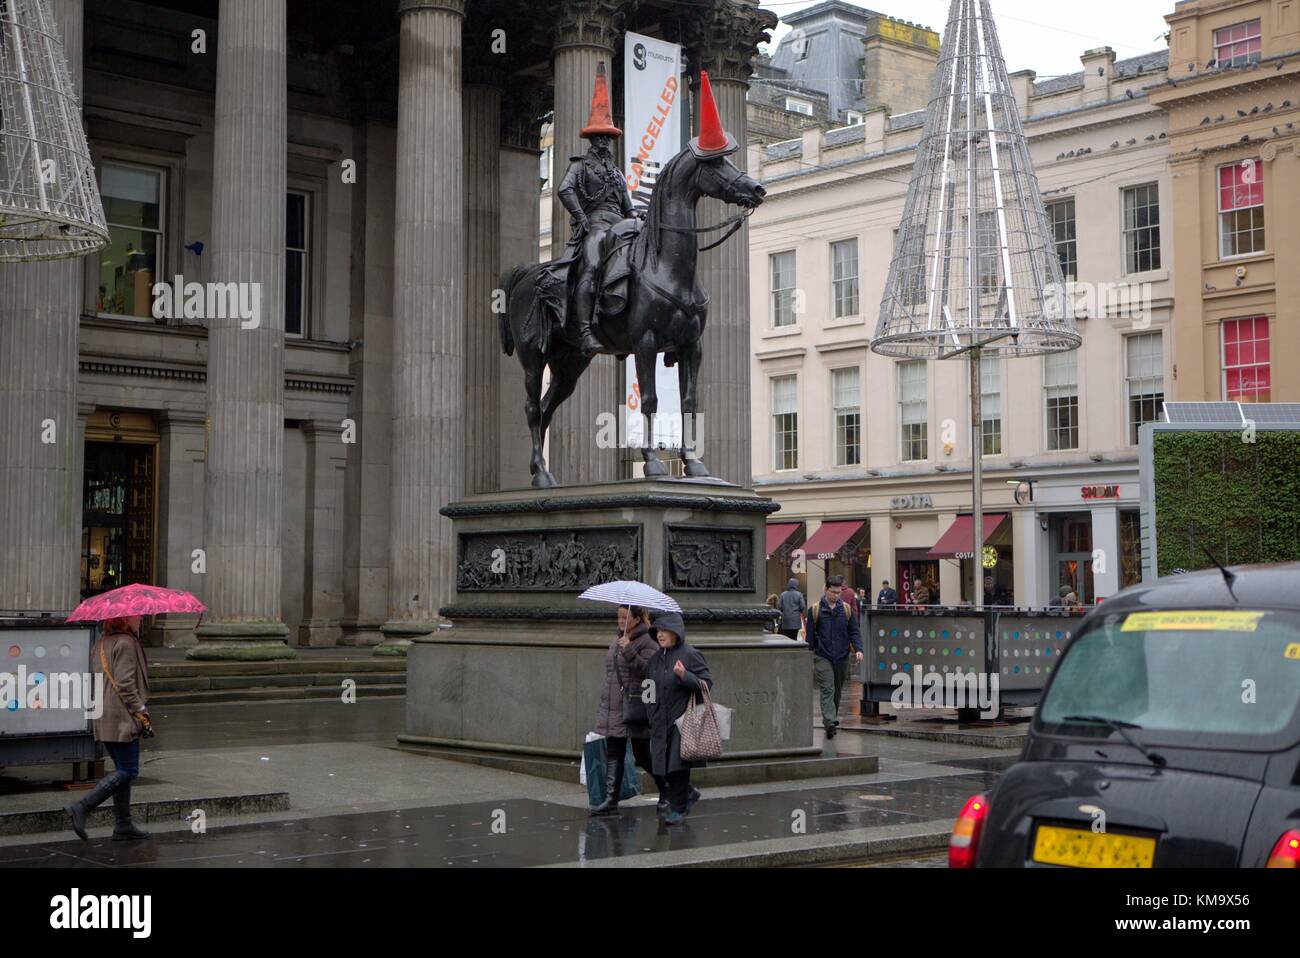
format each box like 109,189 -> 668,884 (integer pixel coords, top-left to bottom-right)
399,480 -> 820,759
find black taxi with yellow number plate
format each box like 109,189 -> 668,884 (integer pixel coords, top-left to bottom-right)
949,563 -> 1300,868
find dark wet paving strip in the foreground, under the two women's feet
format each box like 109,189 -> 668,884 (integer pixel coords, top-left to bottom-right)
0,771 -> 996,868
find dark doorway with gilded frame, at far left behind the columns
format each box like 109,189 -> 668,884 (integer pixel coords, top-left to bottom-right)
81,412 -> 159,598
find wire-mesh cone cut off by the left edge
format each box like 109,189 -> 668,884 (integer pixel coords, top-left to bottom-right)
0,0 -> 108,263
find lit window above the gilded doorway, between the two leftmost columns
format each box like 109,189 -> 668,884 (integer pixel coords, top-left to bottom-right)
95,161 -> 166,318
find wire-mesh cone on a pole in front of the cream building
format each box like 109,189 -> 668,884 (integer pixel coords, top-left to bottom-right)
871,0 -> 1080,359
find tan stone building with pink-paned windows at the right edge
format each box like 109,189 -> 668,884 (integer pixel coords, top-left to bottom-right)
1151,0 -> 1300,403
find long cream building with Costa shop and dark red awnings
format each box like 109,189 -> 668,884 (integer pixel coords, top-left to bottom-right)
750,42 -> 1175,606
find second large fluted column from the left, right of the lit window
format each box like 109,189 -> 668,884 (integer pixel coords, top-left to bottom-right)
189,0 -> 294,659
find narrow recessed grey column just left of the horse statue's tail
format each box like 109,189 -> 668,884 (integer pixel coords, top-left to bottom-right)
462,76 -> 502,494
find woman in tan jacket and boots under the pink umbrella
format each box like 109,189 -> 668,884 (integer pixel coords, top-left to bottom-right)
64,615 -> 153,841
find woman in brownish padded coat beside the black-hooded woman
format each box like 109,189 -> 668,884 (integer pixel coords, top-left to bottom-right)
590,606 -> 663,815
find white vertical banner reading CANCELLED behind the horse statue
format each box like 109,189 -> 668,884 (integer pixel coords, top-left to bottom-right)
623,34 -> 685,448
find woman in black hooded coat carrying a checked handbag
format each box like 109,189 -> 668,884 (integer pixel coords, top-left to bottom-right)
646,612 -> 714,825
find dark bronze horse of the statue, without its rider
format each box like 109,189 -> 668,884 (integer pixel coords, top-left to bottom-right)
501,108 -> 766,487
